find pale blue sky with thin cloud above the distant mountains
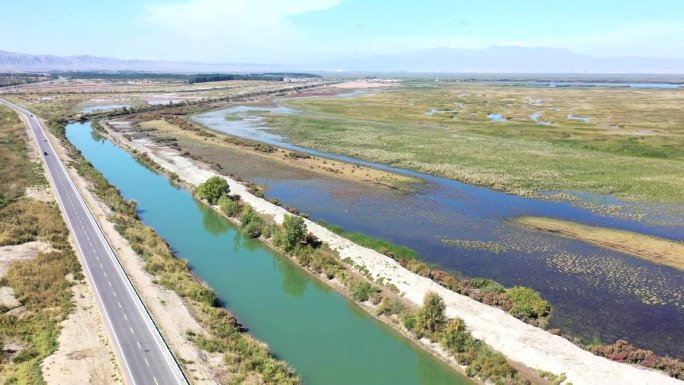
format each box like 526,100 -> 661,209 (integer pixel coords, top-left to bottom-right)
0,0 -> 684,63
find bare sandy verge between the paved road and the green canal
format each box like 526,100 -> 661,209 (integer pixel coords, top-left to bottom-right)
51,118 -> 226,385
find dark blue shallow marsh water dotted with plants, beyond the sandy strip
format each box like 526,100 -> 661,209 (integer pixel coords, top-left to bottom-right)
193,106 -> 684,358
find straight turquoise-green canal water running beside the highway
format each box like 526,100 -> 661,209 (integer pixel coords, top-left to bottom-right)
67,123 -> 471,385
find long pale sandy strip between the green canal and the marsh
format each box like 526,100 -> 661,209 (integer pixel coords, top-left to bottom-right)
112,127 -> 684,385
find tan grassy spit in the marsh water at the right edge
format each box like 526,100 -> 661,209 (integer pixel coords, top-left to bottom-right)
515,217 -> 684,270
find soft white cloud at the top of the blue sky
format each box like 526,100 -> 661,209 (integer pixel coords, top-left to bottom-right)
143,0 -> 341,61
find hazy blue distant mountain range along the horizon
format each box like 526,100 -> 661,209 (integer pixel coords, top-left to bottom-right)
0,46 -> 684,74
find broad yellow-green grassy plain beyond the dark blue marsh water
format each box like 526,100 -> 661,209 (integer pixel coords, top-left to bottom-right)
266,81 -> 684,203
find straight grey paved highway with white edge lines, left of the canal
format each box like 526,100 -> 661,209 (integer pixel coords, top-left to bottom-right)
0,99 -> 188,385
